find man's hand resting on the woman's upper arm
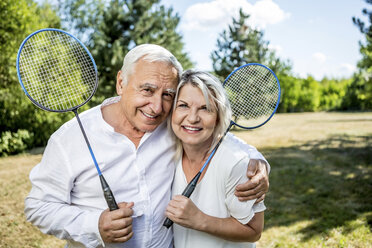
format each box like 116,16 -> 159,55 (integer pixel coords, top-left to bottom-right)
235,159 -> 269,203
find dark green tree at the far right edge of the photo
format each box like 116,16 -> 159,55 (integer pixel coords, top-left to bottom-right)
342,0 -> 372,110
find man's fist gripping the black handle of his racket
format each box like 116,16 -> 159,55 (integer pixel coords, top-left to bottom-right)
98,202 -> 134,243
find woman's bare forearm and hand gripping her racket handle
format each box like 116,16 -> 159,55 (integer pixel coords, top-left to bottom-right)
166,195 -> 264,242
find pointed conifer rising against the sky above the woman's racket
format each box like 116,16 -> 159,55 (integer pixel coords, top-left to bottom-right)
211,9 -> 291,79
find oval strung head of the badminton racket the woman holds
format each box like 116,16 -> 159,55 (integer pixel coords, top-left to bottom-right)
223,63 -> 281,129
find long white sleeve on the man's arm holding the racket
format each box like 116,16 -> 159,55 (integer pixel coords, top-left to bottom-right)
25,138 -> 104,247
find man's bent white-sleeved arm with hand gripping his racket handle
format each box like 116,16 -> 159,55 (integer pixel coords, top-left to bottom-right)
25,138 -> 133,247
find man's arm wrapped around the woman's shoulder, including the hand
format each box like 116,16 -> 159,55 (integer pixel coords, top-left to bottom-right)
227,133 -> 270,202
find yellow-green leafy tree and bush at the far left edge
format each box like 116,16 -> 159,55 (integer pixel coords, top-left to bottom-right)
0,0 -> 66,155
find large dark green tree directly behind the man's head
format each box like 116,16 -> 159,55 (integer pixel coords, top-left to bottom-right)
60,0 -> 192,104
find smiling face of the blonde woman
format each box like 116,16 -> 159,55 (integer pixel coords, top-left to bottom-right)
172,84 -> 217,148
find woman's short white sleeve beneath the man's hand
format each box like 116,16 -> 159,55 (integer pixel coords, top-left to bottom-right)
225,157 -> 256,225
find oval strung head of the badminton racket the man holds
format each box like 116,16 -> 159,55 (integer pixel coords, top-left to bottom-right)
17,28 -> 98,112
